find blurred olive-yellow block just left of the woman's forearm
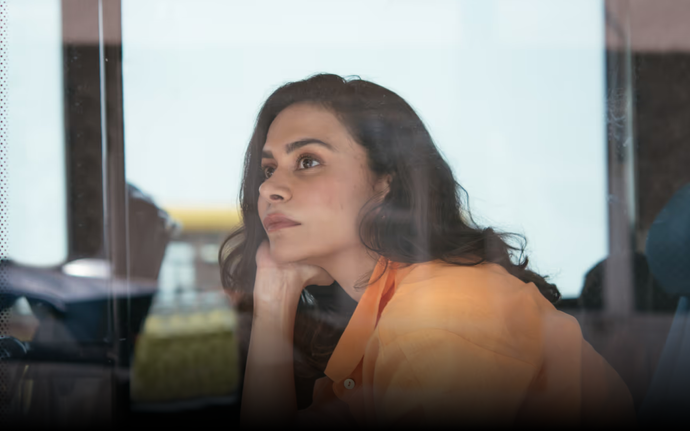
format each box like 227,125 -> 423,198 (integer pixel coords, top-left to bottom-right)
131,292 -> 239,403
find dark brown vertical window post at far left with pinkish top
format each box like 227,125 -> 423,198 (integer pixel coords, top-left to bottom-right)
62,0 -> 104,260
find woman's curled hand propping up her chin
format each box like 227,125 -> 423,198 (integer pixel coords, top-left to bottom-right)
254,240 -> 334,308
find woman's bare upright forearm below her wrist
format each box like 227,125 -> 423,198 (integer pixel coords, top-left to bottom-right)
241,276 -> 301,427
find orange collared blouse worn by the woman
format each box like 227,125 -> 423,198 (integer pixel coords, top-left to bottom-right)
298,258 -> 635,428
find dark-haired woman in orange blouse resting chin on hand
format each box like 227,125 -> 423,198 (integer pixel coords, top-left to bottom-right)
220,75 -> 634,427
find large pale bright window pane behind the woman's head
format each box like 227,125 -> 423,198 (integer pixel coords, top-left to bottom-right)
123,0 -> 607,297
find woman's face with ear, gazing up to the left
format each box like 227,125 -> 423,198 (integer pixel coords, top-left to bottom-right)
258,104 -> 385,265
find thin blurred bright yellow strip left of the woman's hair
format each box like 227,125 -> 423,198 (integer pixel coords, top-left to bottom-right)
165,207 -> 242,232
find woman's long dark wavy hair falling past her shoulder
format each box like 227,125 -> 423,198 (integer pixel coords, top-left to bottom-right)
219,74 -> 560,392
